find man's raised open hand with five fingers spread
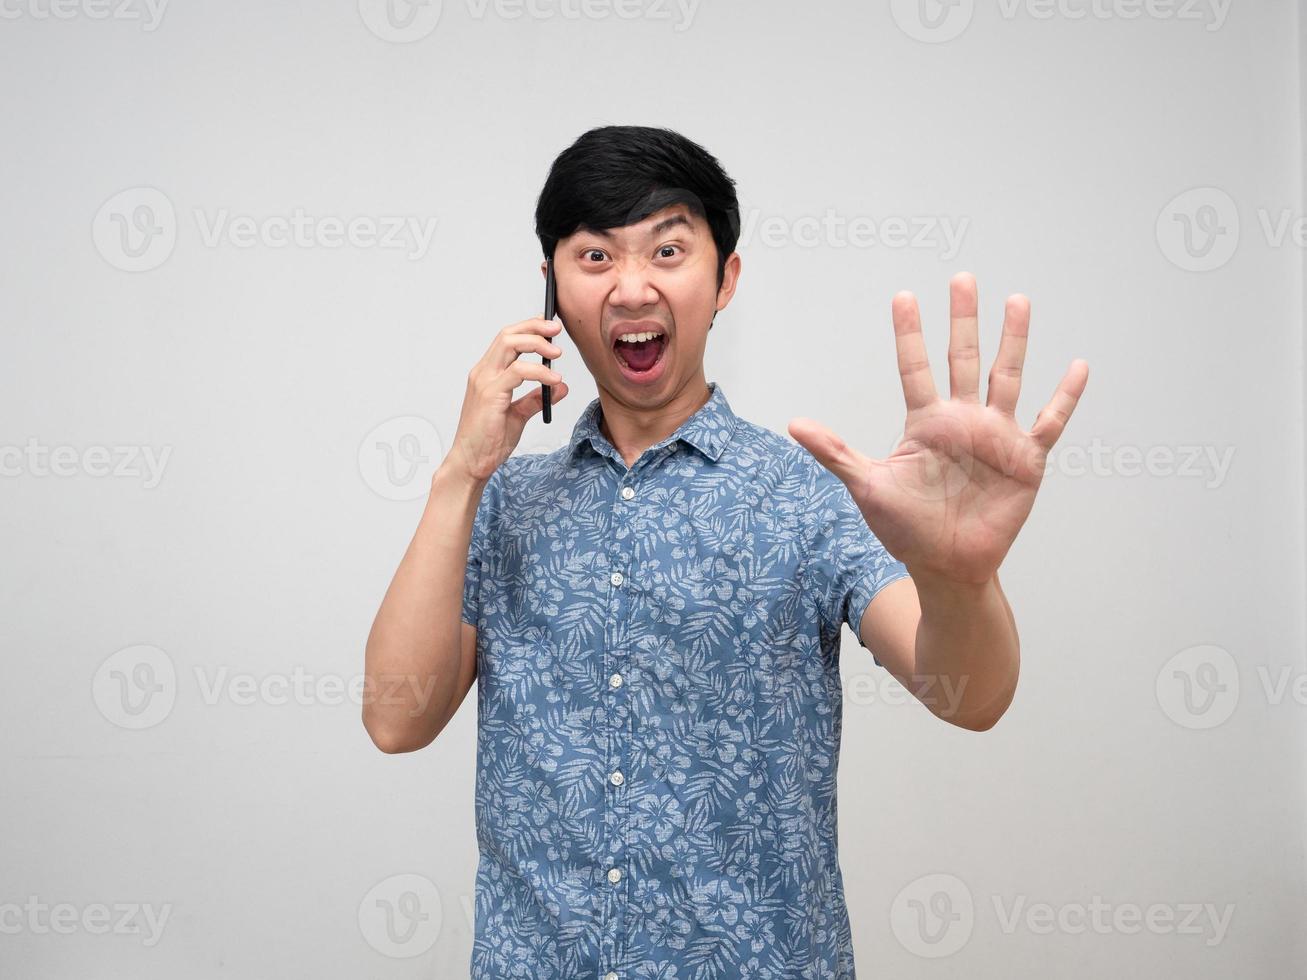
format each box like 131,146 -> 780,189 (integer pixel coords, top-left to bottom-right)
789,273 -> 1089,584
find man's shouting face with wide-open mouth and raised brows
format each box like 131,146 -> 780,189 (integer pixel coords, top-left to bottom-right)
543,204 -> 740,410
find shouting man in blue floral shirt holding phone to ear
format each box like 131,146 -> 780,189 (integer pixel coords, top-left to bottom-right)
363,127 -> 1087,980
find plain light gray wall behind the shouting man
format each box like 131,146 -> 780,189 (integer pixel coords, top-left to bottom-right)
0,0 -> 1307,980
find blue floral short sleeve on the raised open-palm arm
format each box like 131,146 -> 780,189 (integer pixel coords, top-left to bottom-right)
801,459 -> 908,666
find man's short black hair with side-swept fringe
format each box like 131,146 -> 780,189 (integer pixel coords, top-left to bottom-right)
536,125 -> 740,287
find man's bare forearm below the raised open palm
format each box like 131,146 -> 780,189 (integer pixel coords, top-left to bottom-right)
912,574 -> 1021,730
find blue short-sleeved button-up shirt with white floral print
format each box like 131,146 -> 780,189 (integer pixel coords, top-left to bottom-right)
463,382 -> 907,980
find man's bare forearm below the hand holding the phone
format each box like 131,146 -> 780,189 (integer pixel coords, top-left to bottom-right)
363,466 -> 485,751
